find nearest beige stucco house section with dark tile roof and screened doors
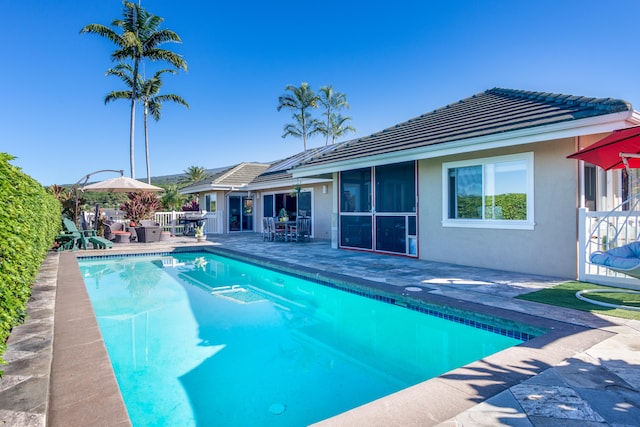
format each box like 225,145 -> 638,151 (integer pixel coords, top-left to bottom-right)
289,88 -> 640,278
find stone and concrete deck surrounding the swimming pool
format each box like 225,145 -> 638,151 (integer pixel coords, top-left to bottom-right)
0,234 -> 640,426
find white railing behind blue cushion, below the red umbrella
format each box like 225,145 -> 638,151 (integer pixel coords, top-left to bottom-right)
578,206 -> 640,289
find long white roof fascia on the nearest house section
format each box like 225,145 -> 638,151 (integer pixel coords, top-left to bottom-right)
289,110 -> 640,178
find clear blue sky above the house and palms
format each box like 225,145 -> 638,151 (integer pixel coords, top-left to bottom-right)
5,0 -> 640,185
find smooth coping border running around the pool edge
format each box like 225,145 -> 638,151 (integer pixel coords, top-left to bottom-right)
3,242 -> 614,426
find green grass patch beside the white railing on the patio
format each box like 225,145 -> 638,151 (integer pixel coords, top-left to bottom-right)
516,282 -> 640,320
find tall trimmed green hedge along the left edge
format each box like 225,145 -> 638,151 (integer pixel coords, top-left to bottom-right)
0,152 -> 61,374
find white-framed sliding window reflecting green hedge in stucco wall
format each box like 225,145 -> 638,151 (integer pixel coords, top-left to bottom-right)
443,153 -> 534,229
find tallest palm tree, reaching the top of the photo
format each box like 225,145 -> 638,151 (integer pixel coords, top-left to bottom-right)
80,1 -> 187,178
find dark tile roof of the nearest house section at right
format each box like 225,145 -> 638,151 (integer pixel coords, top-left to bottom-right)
294,88 -> 632,167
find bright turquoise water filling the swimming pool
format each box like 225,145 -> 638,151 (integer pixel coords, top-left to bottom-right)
80,252 -> 521,427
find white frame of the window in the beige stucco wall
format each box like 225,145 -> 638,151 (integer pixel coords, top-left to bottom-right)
442,152 -> 535,230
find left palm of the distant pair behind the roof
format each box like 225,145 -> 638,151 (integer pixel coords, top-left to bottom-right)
278,83 -> 319,151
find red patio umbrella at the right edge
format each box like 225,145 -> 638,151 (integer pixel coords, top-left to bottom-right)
567,126 -> 640,170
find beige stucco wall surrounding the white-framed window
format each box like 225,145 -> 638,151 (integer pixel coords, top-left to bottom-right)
419,138 -> 577,278
